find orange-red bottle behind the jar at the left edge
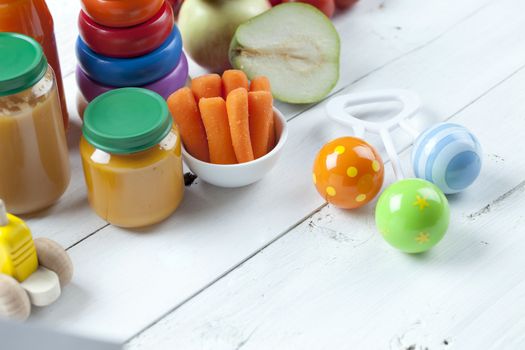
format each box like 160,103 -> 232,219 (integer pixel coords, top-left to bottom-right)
0,0 -> 69,128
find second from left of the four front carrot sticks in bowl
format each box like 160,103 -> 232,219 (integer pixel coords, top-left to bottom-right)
199,97 -> 237,164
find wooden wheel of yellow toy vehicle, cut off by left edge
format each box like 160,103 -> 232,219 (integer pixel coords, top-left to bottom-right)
0,274 -> 31,321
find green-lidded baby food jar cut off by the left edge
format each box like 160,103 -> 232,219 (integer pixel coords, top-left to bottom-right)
0,33 -> 70,214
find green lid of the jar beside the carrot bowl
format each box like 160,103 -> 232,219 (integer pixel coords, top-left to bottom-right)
82,88 -> 173,154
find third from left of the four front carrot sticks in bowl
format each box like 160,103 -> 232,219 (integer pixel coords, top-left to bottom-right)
226,88 -> 254,163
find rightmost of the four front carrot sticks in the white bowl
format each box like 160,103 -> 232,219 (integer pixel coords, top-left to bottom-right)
248,91 -> 275,159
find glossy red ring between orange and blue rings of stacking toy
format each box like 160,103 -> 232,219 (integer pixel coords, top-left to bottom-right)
78,3 -> 175,58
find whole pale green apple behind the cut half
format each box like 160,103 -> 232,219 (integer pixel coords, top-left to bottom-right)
178,0 -> 271,73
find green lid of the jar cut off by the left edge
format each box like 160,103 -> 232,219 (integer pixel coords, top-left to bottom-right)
0,33 -> 48,96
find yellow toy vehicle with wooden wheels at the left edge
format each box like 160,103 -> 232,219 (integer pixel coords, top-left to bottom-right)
0,200 -> 73,321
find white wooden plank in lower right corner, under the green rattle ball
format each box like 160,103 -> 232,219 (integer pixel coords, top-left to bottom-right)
127,52 -> 525,350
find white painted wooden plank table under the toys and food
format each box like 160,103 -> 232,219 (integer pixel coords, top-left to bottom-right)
22,0 -> 525,350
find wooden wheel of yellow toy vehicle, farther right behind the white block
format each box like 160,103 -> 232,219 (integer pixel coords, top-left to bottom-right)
35,238 -> 73,287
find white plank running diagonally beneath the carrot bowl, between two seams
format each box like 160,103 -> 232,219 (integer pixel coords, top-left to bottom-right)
27,0 -> 525,340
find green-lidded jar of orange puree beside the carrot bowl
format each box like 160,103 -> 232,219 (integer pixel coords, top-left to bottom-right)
80,88 -> 184,228
